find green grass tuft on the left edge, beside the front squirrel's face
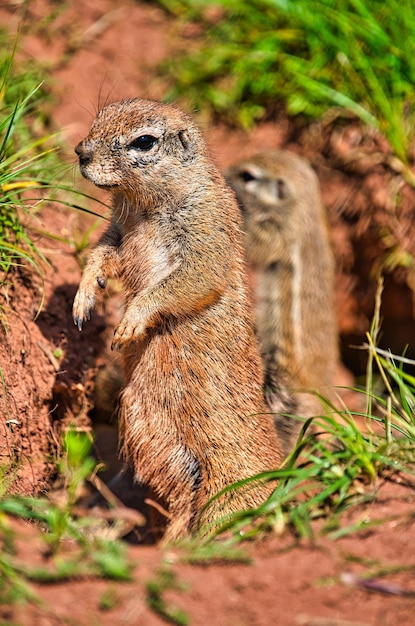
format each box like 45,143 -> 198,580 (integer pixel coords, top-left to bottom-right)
0,31 -> 109,306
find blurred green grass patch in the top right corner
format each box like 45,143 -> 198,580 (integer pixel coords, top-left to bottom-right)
160,0 -> 415,171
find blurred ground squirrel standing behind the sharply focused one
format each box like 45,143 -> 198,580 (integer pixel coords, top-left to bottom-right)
225,150 -> 338,452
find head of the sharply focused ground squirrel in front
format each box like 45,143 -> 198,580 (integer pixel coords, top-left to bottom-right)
75,98 -> 206,197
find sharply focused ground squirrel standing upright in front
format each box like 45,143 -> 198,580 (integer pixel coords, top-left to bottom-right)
73,99 -> 281,540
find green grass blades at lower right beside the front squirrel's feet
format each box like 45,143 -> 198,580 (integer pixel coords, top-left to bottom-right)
197,282 -> 415,540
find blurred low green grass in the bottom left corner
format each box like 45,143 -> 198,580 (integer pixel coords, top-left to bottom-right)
0,430 -> 132,604
